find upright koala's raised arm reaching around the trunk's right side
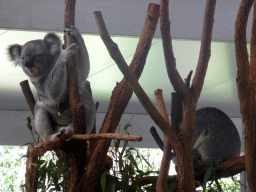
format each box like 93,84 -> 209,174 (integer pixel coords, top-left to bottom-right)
65,25 -> 90,85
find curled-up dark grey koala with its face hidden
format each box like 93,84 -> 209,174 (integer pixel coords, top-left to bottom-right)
150,107 -> 241,169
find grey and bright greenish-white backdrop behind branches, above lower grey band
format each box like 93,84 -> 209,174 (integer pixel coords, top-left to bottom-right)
0,0 -> 252,117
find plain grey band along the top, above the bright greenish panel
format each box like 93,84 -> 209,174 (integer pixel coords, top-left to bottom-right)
0,0 -> 252,41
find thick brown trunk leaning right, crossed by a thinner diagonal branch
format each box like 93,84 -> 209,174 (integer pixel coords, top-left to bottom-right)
82,4 -> 159,192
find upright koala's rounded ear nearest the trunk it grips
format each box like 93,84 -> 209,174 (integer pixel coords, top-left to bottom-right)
44,33 -> 61,55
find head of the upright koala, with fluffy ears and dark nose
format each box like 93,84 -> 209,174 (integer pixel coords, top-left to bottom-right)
8,33 -> 61,78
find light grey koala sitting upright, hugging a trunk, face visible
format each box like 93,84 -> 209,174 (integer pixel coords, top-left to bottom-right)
8,26 -> 96,140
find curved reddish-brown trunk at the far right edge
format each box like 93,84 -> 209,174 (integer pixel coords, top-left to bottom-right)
235,0 -> 256,191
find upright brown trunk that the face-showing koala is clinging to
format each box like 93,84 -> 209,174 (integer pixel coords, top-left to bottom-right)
64,0 -> 88,192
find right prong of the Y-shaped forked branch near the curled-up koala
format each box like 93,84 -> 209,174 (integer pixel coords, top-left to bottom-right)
191,0 -> 216,102
